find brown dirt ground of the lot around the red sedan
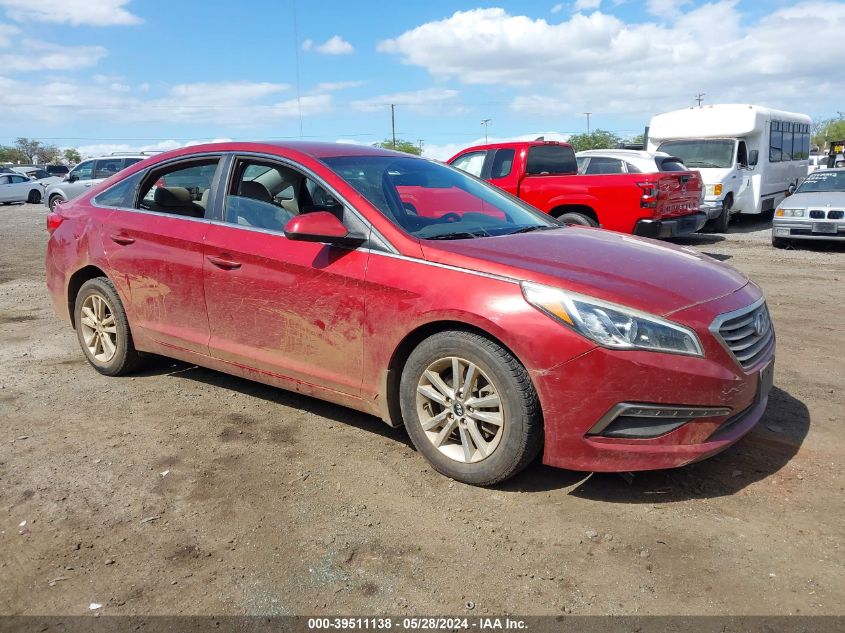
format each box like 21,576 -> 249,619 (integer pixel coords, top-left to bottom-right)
0,205 -> 845,615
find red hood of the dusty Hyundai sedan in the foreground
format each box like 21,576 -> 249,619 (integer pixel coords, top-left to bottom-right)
422,226 -> 748,316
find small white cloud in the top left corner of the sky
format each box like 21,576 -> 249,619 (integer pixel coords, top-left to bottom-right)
0,0 -> 142,26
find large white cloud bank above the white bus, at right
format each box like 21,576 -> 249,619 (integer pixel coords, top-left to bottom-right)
378,0 -> 845,118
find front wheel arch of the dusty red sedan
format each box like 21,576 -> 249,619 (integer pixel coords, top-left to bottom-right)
380,319 -> 536,427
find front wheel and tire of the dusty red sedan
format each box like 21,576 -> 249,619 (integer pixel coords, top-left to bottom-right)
399,330 -> 543,486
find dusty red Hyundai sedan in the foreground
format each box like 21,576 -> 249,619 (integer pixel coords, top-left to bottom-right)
46,143 -> 775,485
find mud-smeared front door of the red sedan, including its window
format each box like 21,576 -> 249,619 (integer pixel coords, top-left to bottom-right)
204,158 -> 368,395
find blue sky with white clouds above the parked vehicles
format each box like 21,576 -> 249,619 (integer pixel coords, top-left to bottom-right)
0,0 -> 845,158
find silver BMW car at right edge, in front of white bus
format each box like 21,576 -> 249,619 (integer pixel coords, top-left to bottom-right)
772,167 -> 845,248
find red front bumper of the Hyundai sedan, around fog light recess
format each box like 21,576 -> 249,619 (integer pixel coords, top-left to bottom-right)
534,287 -> 774,472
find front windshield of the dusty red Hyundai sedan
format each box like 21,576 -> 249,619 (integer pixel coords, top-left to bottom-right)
322,156 -> 561,240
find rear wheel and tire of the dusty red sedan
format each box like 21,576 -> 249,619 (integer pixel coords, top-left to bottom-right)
73,277 -> 140,376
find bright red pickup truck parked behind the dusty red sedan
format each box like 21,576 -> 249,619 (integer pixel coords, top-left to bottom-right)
448,141 -> 707,237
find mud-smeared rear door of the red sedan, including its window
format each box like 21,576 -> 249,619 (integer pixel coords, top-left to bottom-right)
93,154 -> 221,354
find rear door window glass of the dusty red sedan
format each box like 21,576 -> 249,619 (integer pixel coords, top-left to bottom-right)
137,157 -> 220,218
